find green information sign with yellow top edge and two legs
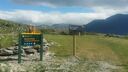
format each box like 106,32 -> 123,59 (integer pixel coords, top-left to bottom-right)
18,33 -> 43,63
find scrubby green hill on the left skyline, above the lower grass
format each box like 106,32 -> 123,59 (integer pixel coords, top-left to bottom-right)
0,19 -> 27,34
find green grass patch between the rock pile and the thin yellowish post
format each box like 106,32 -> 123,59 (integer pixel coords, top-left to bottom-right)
45,35 -> 72,57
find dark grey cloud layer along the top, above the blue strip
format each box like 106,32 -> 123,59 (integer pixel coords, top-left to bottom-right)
12,0 -> 128,8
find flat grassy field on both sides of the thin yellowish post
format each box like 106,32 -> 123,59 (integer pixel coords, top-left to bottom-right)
45,35 -> 128,69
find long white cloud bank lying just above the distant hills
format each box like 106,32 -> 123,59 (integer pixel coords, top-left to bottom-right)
0,10 -> 111,24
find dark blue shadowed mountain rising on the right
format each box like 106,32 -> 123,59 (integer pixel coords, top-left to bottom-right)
85,14 -> 128,35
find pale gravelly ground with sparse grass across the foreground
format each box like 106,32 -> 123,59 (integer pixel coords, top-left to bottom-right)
0,52 -> 124,72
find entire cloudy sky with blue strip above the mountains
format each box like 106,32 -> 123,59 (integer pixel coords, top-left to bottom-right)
0,0 -> 128,25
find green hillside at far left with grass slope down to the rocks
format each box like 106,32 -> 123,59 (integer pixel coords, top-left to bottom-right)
0,19 -> 27,48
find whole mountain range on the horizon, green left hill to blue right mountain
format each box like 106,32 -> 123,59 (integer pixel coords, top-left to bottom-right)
0,14 -> 128,35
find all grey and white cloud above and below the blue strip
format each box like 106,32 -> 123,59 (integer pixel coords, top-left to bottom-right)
3,0 -> 128,24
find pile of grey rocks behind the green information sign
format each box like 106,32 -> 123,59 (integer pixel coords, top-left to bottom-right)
0,39 -> 51,56
